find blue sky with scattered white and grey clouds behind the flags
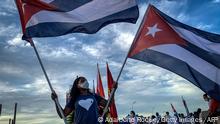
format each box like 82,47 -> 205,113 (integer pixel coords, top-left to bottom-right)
0,0 -> 220,124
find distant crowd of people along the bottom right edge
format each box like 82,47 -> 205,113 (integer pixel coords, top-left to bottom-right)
119,94 -> 220,124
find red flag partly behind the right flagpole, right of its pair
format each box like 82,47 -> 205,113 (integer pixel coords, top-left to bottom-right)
106,63 -> 118,124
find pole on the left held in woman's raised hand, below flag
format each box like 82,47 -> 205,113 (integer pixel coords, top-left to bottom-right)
28,39 -> 67,124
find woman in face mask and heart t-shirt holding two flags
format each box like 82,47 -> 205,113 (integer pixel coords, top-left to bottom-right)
51,77 -> 116,124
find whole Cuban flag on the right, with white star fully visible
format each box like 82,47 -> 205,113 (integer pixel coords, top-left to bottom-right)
128,5 -> 220,101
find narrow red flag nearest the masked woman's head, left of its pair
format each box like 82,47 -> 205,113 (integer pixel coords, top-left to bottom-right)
96,64 -> 105,98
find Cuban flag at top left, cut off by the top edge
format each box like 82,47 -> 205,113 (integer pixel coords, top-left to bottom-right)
15,0 -> 139,39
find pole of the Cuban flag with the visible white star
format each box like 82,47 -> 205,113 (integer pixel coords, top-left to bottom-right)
102,5 -> 150,118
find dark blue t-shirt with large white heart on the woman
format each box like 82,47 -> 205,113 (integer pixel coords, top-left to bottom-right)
66,94 -> 101,124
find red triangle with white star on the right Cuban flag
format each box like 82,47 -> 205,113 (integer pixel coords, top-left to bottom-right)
128,5 -> 186,57
